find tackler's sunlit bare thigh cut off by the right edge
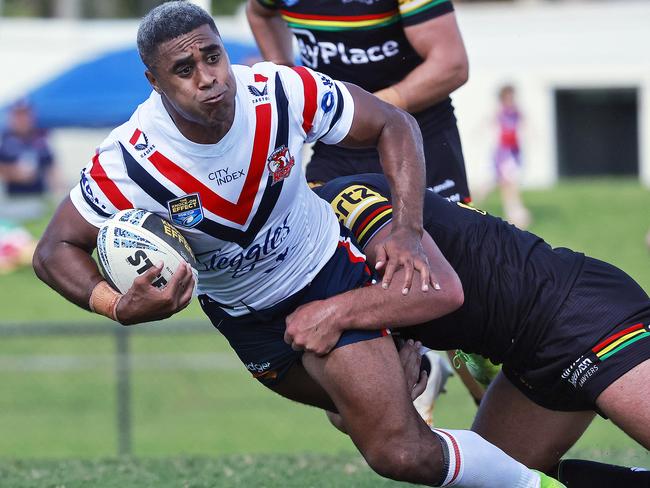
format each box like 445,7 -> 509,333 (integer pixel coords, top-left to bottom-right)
596,359 -> 650,449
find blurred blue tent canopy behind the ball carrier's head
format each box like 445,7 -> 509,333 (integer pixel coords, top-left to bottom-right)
0,40 -> 259,129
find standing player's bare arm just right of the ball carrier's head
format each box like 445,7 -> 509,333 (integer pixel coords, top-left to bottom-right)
246,0 -> 293,66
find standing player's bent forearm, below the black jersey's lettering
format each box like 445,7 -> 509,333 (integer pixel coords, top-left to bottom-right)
377,60 -> 468,113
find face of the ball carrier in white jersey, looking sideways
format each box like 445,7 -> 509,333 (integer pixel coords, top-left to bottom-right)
146,24 -> 237,142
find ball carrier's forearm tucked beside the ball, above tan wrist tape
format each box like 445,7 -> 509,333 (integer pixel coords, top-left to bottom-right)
33,241 -> 104,310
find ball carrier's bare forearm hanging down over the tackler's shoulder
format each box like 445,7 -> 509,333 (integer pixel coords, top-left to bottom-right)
377,110 -> 426,235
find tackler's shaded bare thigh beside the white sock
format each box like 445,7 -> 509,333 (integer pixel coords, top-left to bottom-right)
472,372 -> 594,471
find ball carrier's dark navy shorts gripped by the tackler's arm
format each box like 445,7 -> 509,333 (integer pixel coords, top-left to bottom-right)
199,227 -> 388,386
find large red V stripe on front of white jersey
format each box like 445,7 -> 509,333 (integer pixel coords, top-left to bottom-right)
149,103 -> 271,225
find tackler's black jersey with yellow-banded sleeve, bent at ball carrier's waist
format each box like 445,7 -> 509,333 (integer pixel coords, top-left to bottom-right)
315,174 -> 584,367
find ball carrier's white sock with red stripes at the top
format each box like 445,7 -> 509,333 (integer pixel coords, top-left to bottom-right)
432,429 -> 540,488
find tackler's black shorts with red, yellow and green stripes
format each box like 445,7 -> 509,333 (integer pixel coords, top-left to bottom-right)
503,257 -> 650,411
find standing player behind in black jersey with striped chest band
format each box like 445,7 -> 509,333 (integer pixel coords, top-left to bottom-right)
246,0 -> 469,202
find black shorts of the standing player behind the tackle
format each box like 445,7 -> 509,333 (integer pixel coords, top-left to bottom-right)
306,124 -> 471,203
